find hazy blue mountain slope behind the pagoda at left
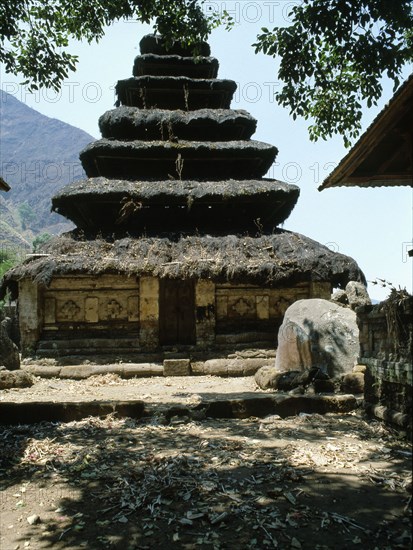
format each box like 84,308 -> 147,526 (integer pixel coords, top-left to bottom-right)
0,90 -> 94,250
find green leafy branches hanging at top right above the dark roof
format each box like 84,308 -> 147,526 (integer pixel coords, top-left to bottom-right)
254,0 -> 413,146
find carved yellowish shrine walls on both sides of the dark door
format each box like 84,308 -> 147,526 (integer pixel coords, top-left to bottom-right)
19,275 -> 331,356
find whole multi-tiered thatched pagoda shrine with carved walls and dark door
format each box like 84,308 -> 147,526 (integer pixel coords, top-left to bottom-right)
3,35 -> 365,359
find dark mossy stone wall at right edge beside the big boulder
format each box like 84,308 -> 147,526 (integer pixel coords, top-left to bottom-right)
357,297 -> 413,434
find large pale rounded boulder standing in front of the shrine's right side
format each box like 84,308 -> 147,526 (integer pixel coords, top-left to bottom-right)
275,299 -> 359,378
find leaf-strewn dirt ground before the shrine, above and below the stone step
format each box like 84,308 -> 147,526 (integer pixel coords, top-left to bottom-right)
0,374 -> 412,550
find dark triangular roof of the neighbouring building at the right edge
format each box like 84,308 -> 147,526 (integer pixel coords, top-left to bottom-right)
318,75 -> 413,191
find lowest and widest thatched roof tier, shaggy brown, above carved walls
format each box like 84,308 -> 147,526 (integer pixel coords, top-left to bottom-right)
2,230 -> 365,295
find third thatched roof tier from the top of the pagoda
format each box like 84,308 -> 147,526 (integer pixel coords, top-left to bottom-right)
116,76 -> 237,111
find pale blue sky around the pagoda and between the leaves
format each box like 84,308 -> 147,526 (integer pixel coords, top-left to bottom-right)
0,0 -> 413,299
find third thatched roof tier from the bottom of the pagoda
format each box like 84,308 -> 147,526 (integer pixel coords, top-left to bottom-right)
79,139 -> 278,180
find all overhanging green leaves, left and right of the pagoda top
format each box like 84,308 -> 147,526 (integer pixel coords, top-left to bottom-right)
0,0 -> 413,146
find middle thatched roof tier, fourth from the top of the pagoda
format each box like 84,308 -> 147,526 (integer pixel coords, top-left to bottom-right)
99,106 -> 257,141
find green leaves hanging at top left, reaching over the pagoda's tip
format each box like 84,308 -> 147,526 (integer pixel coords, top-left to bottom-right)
0,0 -> 225,90
